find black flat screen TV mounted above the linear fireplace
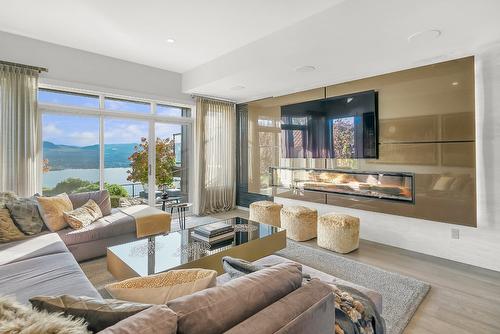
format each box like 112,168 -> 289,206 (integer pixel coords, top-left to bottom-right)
281,91 -> 378,159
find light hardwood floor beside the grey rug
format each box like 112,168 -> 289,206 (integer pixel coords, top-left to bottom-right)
229,210 -> 500,334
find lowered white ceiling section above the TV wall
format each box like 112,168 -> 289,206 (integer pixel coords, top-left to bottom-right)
183,0 -> 500,102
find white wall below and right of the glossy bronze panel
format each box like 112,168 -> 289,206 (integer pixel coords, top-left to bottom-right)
275,45 -> 500,271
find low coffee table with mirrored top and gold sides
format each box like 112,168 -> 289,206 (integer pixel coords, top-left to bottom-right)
107,218 -> 286,280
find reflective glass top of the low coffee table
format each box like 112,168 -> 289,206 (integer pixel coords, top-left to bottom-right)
108,217 -> 285,276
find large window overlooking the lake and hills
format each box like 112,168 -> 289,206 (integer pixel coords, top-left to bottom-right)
39,88 -> 192,206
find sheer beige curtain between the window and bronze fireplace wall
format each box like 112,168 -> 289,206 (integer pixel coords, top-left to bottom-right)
196,97 -> 236,214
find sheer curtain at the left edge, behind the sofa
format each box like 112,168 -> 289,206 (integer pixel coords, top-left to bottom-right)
0,64 -> 40,196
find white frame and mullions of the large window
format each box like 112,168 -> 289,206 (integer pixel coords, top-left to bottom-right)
37,83 -> 196,206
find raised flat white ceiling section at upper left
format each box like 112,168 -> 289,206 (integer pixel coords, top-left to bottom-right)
0,0 -> 340,73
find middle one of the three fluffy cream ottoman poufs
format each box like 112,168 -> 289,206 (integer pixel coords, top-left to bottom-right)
281,206 -> 318,241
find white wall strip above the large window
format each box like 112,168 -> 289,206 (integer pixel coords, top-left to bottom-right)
0,32 -> 193,104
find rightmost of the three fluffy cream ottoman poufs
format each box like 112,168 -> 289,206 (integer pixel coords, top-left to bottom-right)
318,213 -> 359,253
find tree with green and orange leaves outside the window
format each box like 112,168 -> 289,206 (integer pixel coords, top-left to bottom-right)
127,138 -> 176,187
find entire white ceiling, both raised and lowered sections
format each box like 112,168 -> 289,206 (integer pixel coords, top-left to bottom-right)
0,0 -> 500,101
